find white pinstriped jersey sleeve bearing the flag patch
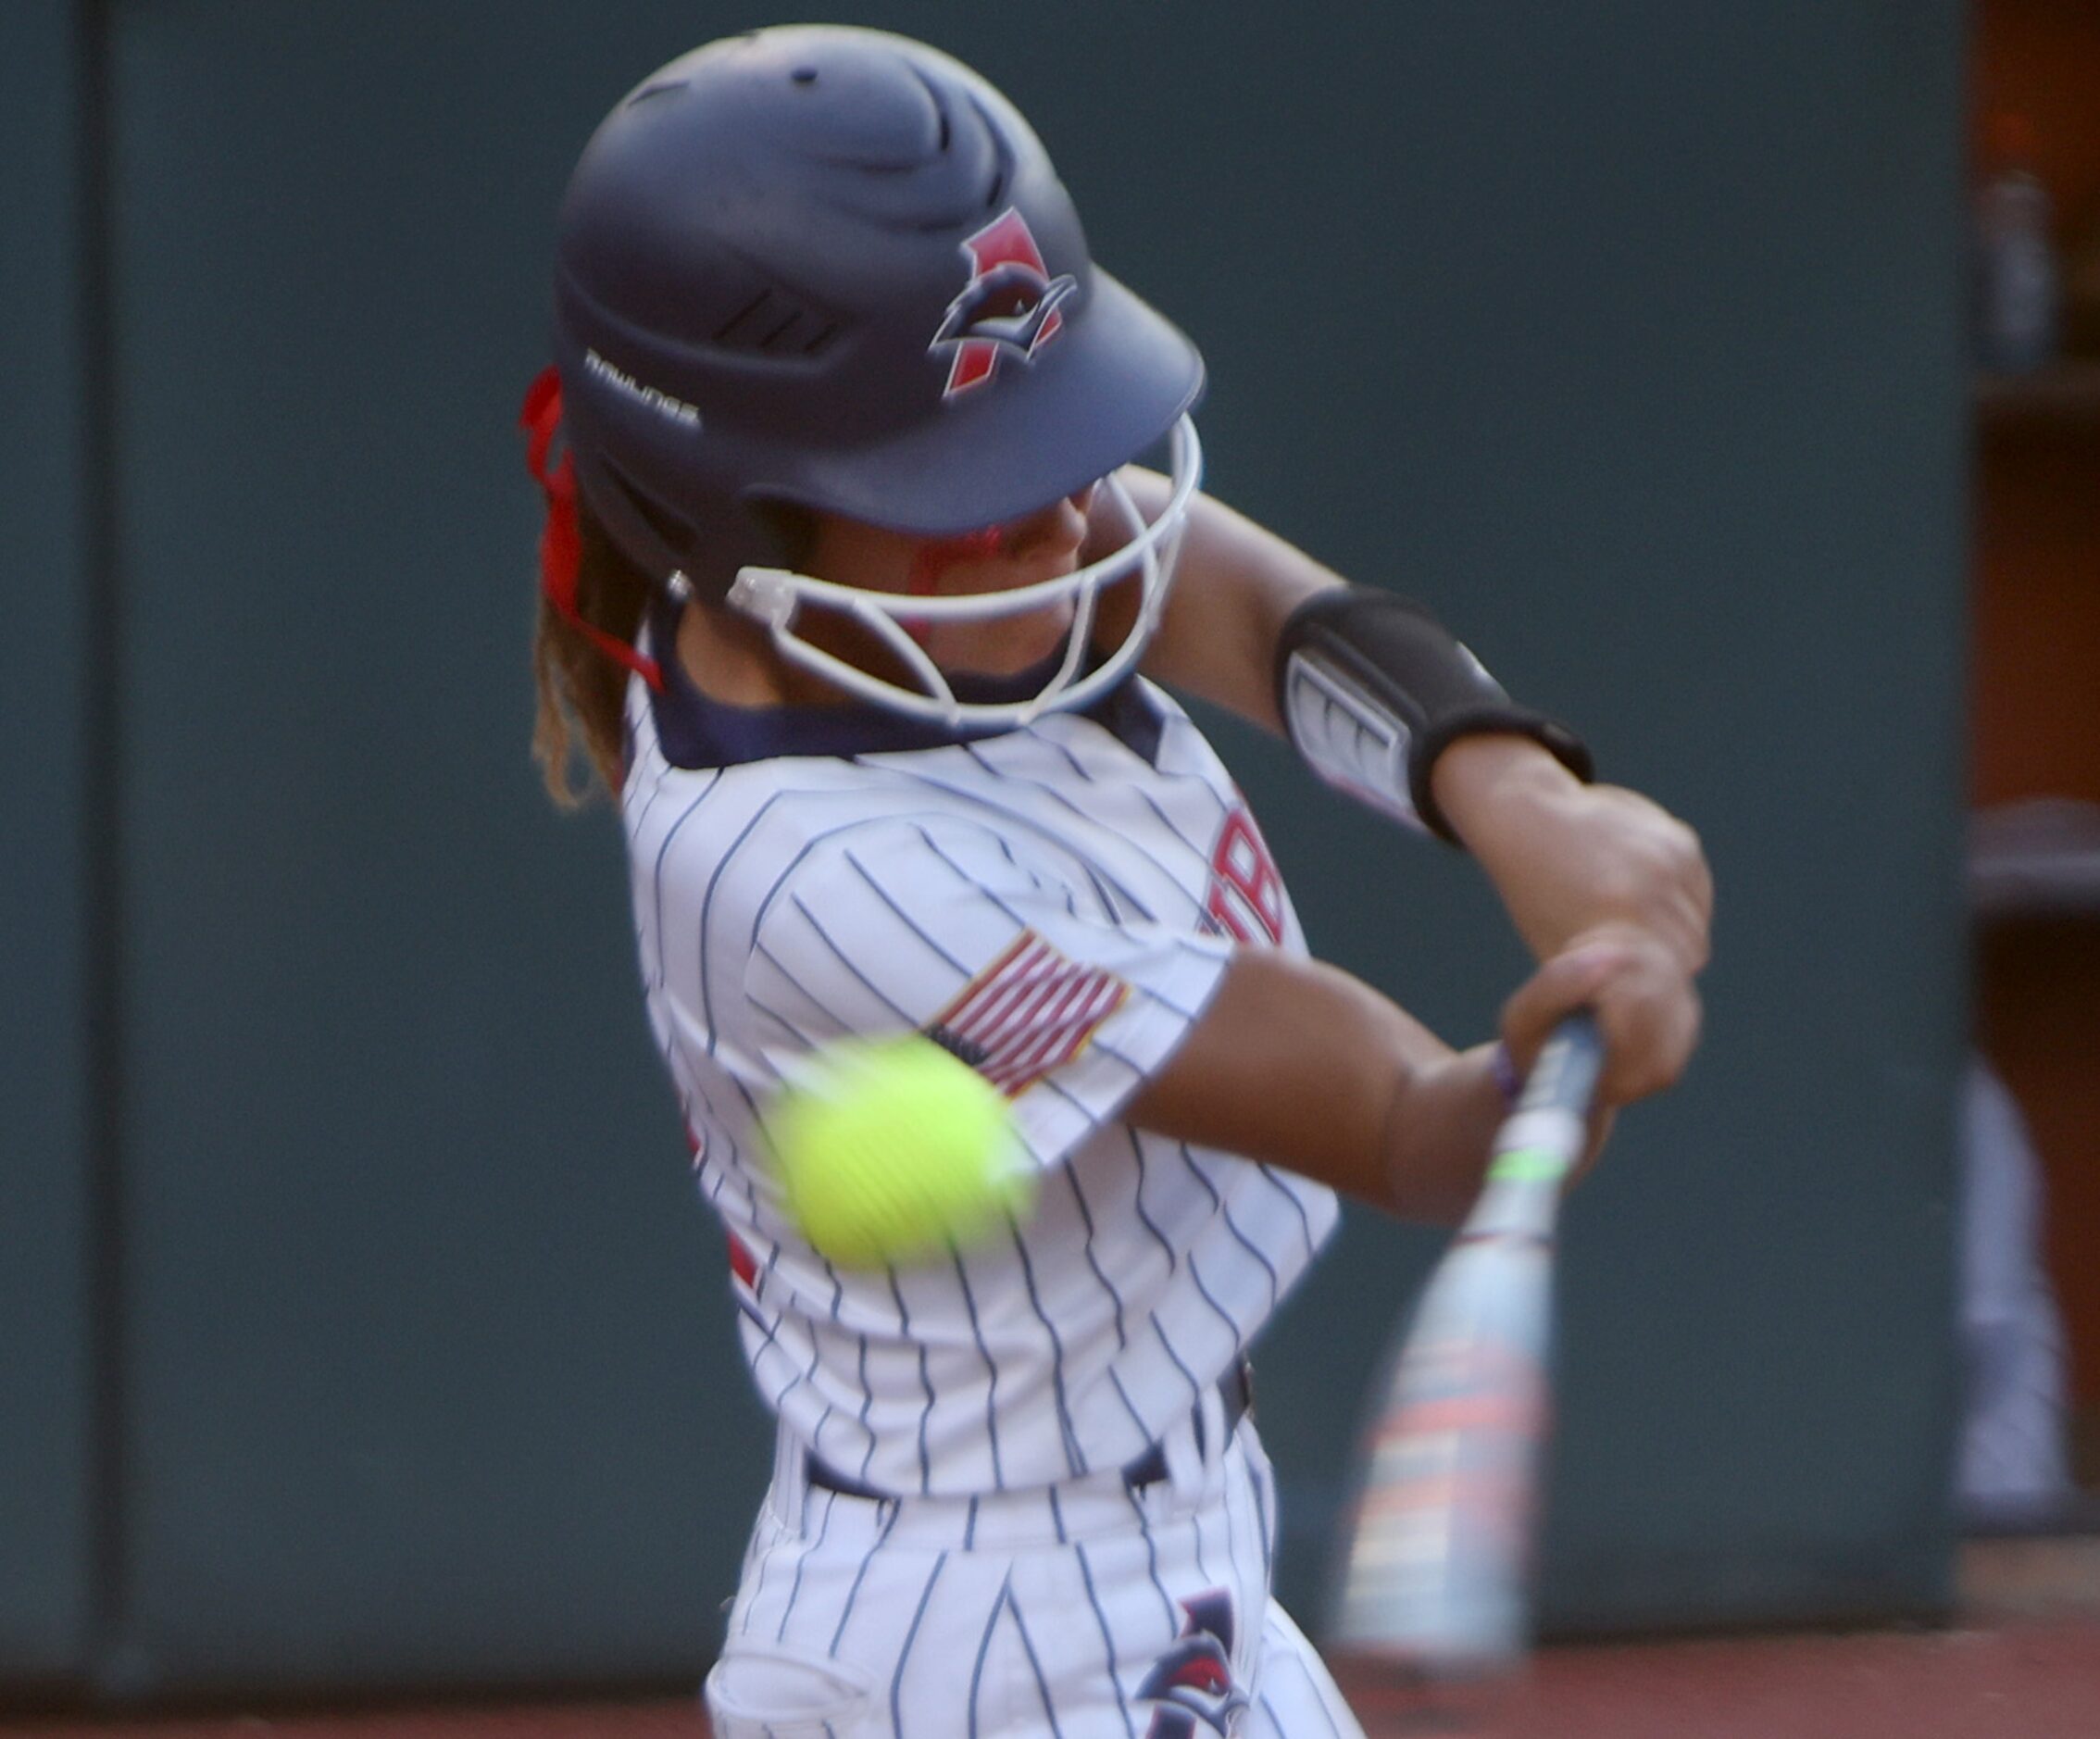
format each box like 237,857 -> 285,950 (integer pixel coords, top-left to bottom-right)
745,819 -> 1232,1166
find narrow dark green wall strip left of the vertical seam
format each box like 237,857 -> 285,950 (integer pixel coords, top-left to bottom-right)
0,0 -> 94,1684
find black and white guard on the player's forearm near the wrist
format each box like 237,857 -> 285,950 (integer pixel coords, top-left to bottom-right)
1277,586 -> 1592,844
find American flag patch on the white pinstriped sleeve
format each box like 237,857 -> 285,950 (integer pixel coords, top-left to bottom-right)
926,931 -> 1130,1098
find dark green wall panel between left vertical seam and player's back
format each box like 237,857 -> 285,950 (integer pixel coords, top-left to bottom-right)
105,5 -> 762,1693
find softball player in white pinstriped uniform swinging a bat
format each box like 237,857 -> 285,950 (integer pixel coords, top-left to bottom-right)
525,27 -> 1709,1739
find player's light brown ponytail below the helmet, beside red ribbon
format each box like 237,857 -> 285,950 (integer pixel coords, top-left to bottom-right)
531,502 -> 656,808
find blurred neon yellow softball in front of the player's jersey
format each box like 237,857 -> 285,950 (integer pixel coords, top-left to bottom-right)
765,1033 -> 1035,1269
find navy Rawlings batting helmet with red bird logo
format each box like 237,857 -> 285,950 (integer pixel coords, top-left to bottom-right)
537,25 -> 1204,716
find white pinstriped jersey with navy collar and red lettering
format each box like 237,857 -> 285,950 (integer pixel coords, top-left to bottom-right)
621,621 -> 1338,1495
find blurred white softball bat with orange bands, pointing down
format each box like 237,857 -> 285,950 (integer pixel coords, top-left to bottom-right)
1330,1015 -> 1602,1680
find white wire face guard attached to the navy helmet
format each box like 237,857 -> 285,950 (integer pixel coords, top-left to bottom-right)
729,416 -> 1204,729
